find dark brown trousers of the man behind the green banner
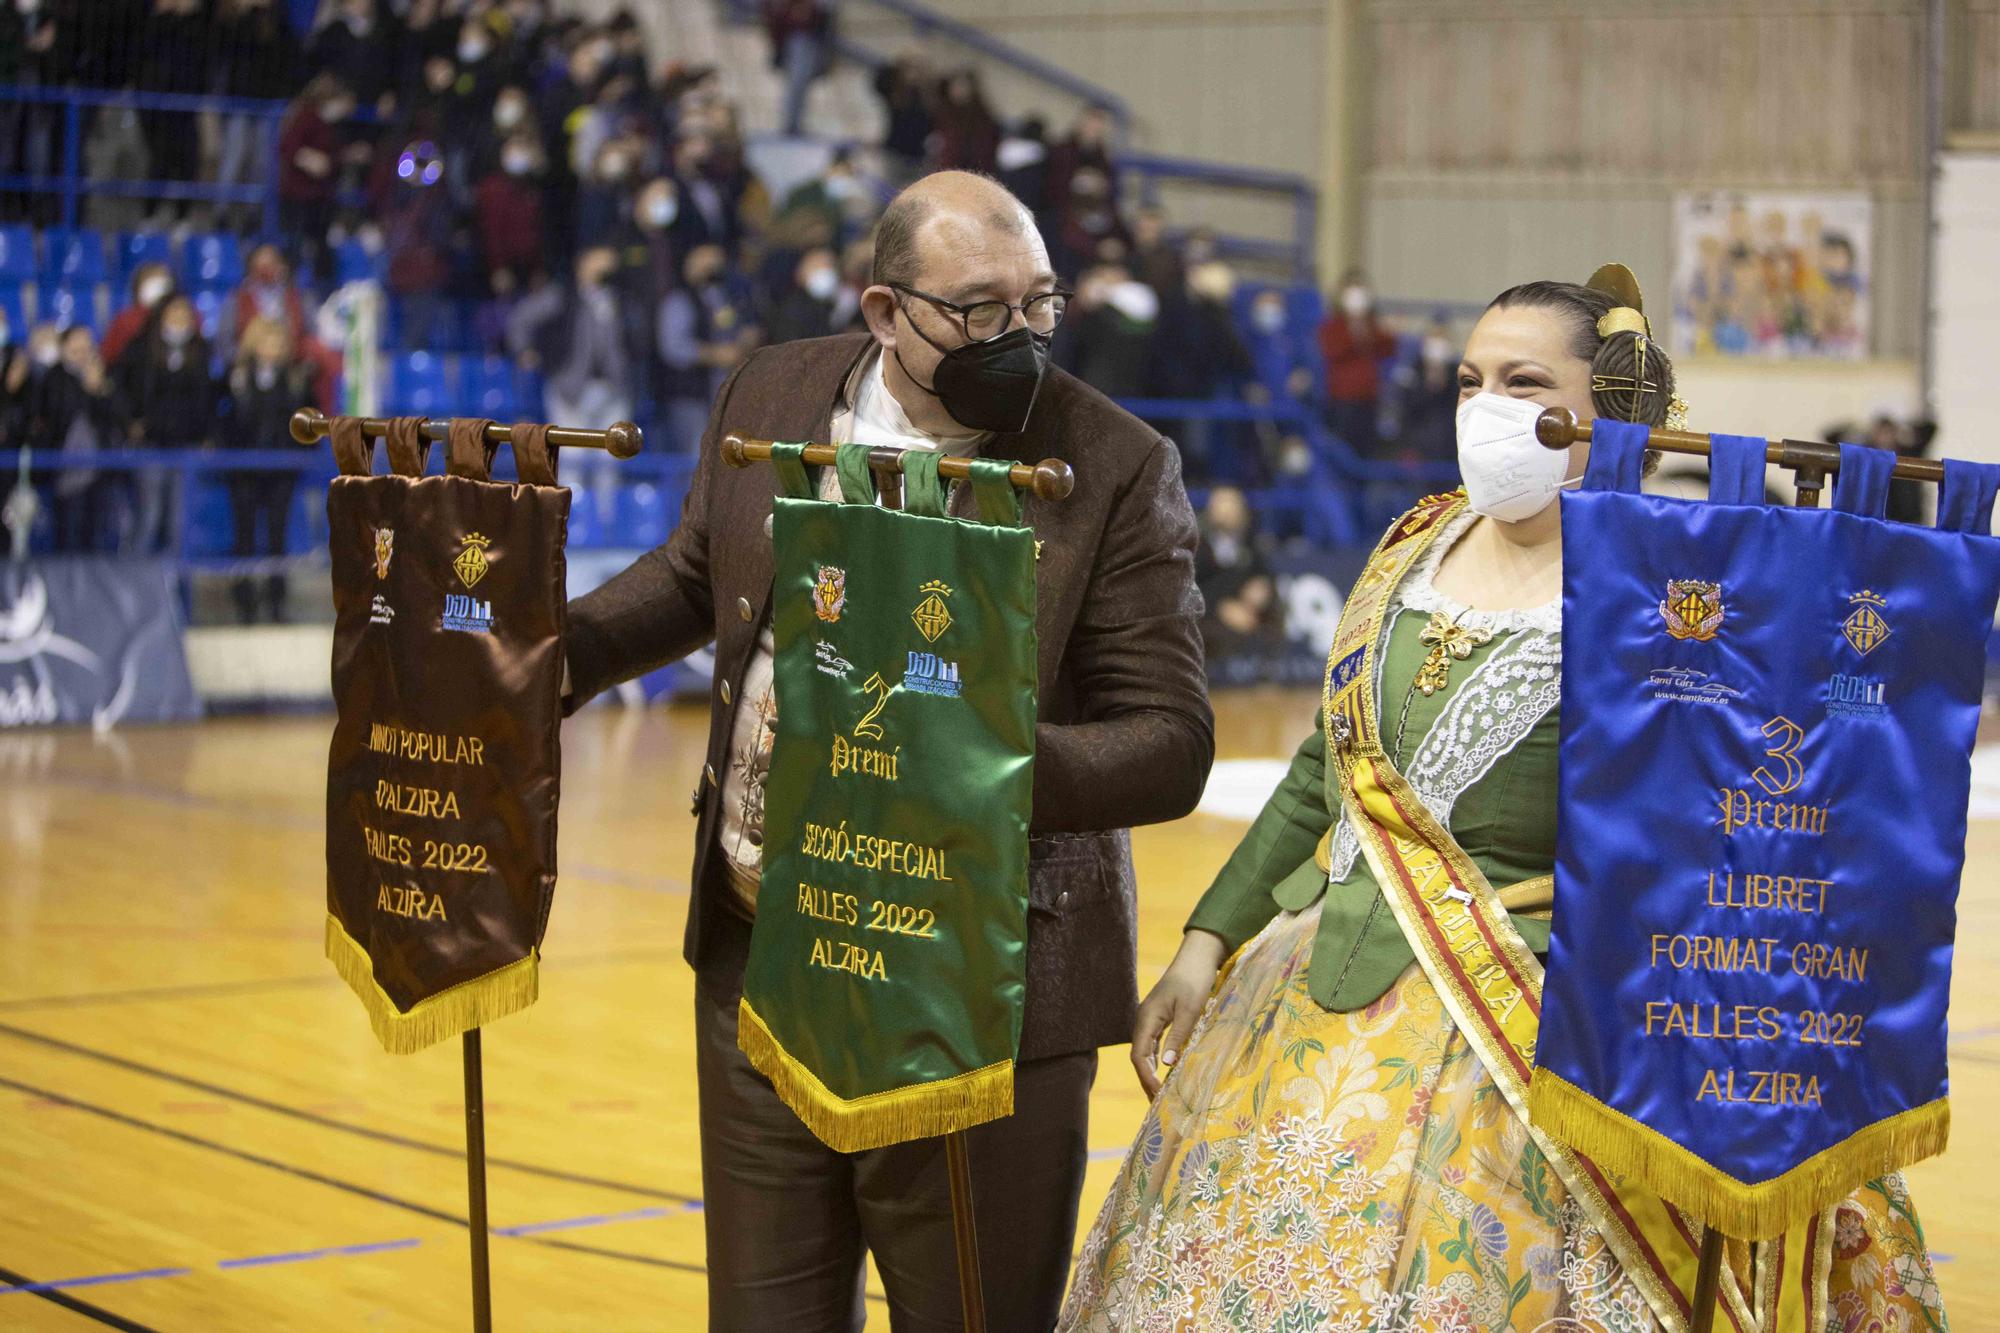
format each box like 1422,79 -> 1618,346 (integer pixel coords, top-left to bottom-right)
694,981 -> 1098,1333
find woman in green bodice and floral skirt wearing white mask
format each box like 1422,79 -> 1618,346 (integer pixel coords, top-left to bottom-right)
1058,266 -> 1946,1333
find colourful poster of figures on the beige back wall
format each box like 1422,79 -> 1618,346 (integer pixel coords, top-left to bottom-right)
1674,192 -> 1874,360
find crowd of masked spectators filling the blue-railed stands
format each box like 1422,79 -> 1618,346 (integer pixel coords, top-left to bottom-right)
0,0 -> 1456,580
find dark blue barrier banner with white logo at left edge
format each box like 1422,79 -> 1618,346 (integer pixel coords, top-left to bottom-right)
0,556 -> 202,731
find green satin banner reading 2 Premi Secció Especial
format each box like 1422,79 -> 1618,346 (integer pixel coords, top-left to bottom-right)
738,444 -> 1036,1153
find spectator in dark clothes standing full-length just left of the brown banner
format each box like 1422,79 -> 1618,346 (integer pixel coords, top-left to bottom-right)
224,318 -> 312,624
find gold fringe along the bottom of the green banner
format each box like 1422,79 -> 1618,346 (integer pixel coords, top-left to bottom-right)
736,999 -> 1014,1153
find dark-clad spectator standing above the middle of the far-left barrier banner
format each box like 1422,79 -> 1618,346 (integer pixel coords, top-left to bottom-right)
34,324 -> 132,554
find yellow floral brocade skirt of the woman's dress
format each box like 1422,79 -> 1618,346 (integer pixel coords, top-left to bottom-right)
1058,907 -> 1946,1333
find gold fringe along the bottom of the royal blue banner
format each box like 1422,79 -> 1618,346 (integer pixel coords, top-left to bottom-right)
1528,1069 -> 1952,1241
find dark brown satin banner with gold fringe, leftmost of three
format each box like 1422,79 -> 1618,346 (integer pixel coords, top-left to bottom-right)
326,418 -> 570,1051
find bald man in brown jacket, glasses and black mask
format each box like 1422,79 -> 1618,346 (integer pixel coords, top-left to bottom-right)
568,172 -> 1214,1333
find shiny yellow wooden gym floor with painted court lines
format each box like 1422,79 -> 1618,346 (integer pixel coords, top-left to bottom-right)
0,693 -> 2000,1331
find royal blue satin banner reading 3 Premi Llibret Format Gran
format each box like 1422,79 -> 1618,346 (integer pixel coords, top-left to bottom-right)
1530,420 -> 2000,1237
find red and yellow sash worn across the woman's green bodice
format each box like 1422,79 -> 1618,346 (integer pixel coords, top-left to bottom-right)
1322,492 -> 1832,1333
